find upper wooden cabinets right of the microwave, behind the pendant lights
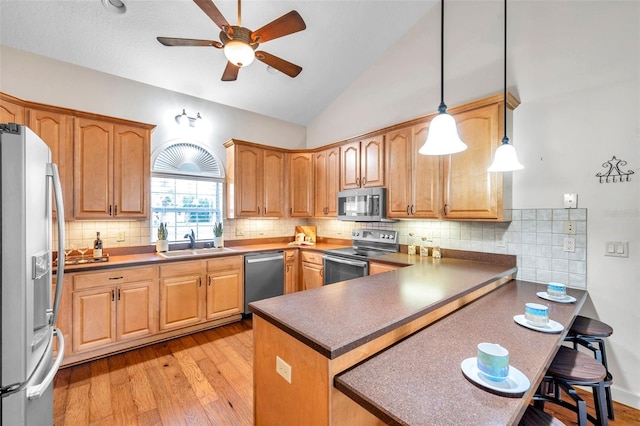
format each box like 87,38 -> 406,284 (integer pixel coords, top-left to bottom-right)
385,95 -> 518,221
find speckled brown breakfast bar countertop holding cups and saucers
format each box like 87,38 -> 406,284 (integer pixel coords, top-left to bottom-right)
334,280 -> 587,425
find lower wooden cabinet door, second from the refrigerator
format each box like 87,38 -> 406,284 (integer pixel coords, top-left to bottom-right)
116,281 -> 155,340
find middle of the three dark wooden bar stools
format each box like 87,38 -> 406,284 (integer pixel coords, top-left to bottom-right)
533,346 -> 608,426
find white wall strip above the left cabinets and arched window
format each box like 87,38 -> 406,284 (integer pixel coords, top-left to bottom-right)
0,46 -> 306,163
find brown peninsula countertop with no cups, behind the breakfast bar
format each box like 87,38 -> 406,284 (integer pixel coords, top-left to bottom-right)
249,254 -> 516,359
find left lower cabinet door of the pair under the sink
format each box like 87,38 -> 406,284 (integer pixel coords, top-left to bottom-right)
160,275 -> 202,330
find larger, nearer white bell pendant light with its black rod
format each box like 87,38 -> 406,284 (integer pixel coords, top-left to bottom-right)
418,0 -> 467,155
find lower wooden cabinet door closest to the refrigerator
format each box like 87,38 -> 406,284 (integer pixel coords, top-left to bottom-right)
72,287 -> 116,352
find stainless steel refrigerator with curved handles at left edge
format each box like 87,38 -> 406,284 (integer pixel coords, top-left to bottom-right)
0,123 -> 65,426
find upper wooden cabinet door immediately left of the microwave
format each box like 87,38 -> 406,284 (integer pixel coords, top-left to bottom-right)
313,147 -> 340,217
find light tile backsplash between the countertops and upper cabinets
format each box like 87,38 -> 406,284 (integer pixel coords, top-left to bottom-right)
57,209 -> 587,288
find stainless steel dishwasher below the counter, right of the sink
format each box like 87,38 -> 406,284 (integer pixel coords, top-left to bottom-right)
244,251 -> 284,314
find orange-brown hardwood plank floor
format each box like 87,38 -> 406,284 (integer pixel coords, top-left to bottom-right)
53,320 -> 640,426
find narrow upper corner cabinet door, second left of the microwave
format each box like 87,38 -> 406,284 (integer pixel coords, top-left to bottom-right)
288,152 -> 313,217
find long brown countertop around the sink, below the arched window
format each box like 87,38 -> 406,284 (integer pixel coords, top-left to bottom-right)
54,243 -> 347,273
